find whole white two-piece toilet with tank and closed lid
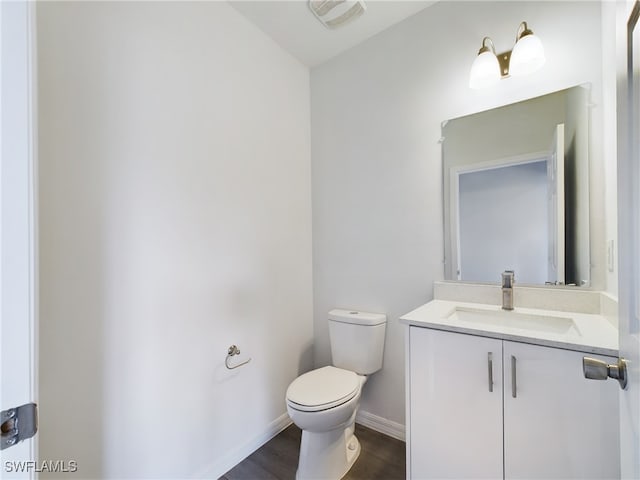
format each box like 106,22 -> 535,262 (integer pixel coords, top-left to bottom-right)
286,310 -> 387,480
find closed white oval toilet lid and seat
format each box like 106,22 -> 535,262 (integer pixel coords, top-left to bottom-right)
287,366 -> 360,411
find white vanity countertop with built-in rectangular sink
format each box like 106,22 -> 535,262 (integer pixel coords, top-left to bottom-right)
400,300 -> 618,357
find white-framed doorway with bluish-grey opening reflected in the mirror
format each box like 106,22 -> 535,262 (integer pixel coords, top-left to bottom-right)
456,156 -> 552,284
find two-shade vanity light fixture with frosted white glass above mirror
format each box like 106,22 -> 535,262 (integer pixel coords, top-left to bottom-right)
469,22 -> 545,89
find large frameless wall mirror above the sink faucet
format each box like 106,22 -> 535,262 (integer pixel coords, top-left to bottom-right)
442,85 -> 590,286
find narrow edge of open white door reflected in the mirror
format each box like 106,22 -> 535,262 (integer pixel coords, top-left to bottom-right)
547,123 -> 565,283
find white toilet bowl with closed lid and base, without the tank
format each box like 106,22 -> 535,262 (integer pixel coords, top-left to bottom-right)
287,366 -> 367,480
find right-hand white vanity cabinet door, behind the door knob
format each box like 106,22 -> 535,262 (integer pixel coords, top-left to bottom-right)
503,341 -> 620,479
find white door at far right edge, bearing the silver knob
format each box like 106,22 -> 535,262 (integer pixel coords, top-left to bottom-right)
617,1 -> 640,479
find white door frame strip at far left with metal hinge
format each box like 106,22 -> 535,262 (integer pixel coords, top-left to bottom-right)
0,2 -> 36,478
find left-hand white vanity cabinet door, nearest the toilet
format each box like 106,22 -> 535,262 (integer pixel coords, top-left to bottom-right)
409,327 -> 502,480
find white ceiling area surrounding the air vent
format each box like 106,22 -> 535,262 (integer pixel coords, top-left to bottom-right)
229,0 -> 435,67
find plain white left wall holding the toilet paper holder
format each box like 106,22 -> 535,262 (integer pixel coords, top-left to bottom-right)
37,2 -> 313,478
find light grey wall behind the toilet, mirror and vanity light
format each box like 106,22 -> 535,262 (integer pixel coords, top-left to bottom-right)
311,2 -> 613,423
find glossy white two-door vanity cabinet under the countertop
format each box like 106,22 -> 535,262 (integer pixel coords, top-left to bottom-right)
407,326 -> 620,480
